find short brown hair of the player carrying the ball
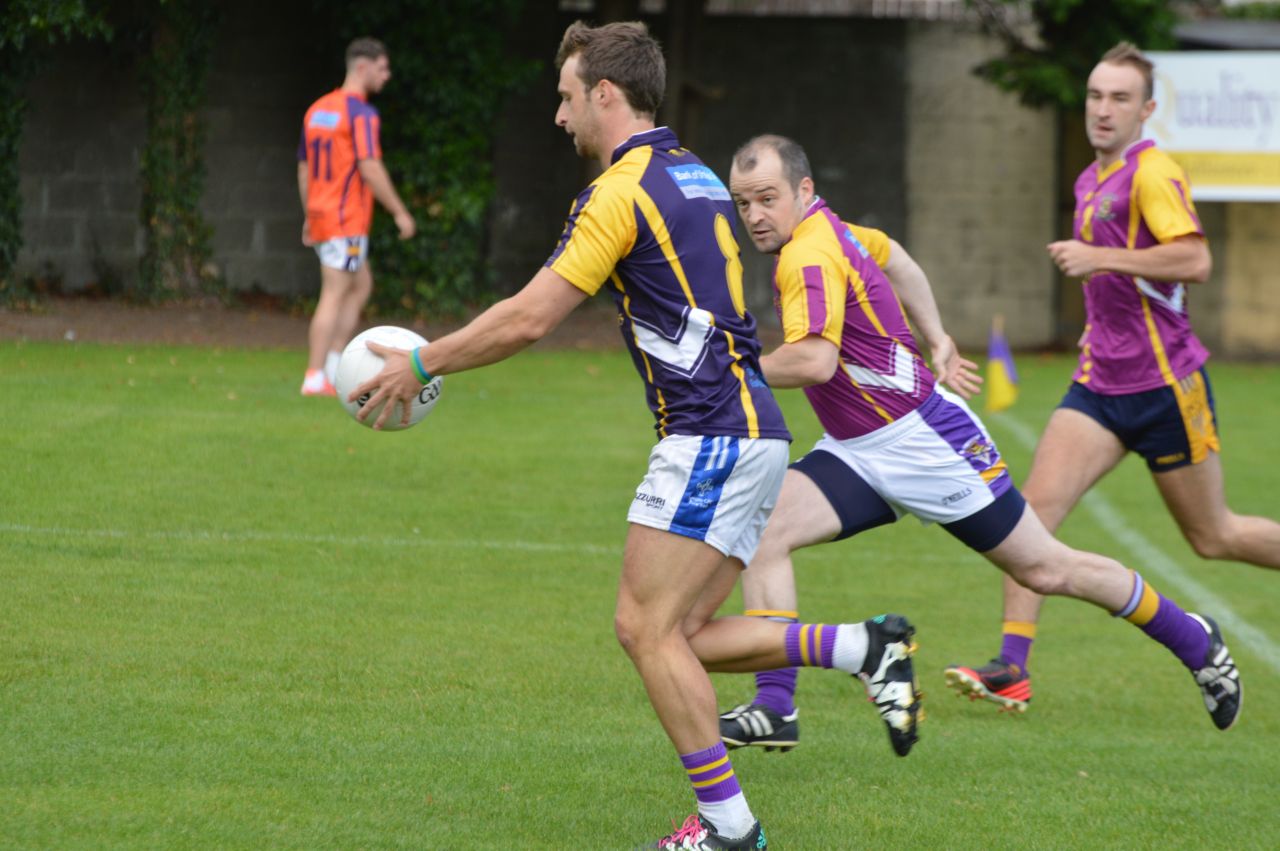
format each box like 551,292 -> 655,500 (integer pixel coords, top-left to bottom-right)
556,20 -> 667,118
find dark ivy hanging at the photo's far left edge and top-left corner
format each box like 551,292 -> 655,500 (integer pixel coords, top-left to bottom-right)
0,0 -> 111,305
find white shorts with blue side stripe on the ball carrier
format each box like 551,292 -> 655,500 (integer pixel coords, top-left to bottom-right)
627,434 -> 788,564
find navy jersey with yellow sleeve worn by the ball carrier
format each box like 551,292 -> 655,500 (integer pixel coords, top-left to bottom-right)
545,127 -> 791,440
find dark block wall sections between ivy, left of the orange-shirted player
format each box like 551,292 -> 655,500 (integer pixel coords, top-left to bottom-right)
18,0 -> 327,294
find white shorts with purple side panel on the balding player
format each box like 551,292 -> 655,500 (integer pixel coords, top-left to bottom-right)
797,388 -> 1021,523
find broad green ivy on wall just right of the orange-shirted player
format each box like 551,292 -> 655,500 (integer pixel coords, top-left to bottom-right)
320,0 -> 536,316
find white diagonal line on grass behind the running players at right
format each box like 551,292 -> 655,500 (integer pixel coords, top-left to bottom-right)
988,413 -> 1280,673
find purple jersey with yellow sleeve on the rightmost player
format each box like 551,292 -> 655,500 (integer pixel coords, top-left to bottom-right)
1074,139 -> 1208,395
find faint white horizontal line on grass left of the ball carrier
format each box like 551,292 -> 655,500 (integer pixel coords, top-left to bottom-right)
0,523 -> 621,555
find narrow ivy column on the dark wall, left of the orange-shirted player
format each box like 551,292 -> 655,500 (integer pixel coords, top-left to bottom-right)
129,0 -> 219,301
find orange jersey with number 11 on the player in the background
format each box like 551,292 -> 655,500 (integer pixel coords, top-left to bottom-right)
298,88 -> 383,242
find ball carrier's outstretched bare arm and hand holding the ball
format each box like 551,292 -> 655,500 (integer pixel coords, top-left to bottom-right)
349,267 -> 586,429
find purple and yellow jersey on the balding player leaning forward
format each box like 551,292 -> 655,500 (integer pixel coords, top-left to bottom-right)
773,198 -> 934,440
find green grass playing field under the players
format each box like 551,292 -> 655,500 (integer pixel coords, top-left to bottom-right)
0,342 -> 1280,850
